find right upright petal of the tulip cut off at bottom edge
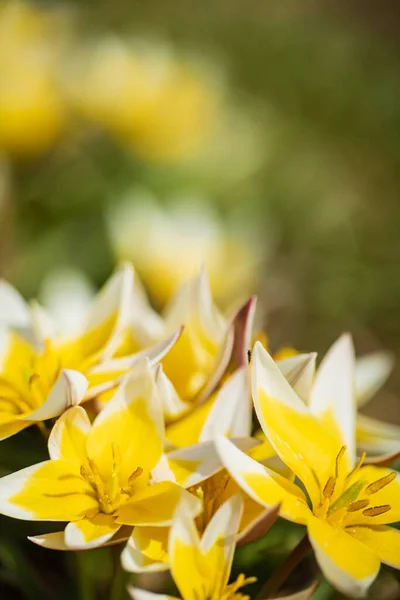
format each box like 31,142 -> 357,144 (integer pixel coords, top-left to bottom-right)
200,495 -> 243,593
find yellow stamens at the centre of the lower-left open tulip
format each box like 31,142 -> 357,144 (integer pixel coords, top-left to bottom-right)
80,443 -> 143,517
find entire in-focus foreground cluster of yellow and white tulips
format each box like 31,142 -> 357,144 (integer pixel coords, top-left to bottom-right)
0,265 -> 400,600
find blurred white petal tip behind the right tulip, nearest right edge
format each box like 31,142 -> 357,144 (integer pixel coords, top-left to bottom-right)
355,352 -> 394,406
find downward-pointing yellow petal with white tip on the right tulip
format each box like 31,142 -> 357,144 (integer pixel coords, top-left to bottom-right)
308,517 -> 381,598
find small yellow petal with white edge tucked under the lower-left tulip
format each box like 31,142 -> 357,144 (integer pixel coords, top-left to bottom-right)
121,527 -> 169,573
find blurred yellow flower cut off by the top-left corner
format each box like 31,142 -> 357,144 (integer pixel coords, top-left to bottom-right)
0,2 -> 66,155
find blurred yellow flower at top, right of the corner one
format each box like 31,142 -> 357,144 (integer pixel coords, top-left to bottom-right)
71,38 -> 219,163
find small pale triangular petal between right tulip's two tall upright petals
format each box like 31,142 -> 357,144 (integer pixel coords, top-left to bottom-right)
276,352 -> 317,404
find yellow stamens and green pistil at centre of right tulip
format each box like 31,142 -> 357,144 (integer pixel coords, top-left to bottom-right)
316,446 -> 396,524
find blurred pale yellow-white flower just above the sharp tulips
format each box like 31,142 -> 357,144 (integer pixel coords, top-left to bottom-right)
108,196 -> 262,306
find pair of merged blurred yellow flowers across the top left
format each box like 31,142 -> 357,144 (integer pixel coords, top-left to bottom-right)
0,1 -> 228,163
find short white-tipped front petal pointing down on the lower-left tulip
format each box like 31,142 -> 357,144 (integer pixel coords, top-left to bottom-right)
65,513 -> 120,550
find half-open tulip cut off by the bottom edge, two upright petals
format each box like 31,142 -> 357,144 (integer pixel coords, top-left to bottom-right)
129,496 -> 255,600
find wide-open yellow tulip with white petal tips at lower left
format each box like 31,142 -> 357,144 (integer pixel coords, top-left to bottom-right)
0,360 -> 201,549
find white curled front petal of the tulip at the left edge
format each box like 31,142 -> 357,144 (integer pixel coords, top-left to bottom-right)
20,369 -> 88,421
